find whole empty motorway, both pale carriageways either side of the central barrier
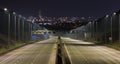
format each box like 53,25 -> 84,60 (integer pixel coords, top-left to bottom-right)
0,37 -> 120,64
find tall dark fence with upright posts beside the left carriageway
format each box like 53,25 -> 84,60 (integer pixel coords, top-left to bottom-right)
0,8 -> 33,46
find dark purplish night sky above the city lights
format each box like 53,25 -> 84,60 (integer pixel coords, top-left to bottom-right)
0,0 -> 120,18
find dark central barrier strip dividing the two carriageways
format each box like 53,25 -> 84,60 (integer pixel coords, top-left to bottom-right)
56,37 -> 71,64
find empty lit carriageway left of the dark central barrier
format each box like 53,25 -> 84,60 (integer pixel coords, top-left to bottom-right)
0,37 -> 57,64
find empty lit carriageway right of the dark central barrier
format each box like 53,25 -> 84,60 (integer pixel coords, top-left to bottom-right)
62,38 -> 120,64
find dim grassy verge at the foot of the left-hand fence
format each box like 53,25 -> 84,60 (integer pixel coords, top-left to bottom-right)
0,33 -> 36,55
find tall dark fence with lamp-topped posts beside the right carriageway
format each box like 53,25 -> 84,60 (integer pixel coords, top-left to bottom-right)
69,11 -> 120,43
